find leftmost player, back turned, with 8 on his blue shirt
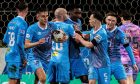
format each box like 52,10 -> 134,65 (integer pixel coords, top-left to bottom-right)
3,2 -> 28,84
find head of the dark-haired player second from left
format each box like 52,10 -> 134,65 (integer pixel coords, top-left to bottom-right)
36,7 -> 49,25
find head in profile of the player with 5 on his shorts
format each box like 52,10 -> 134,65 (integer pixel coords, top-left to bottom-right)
89,11 -> 103,27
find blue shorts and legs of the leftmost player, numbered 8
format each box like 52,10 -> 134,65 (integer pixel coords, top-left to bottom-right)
7,62 -> 22,84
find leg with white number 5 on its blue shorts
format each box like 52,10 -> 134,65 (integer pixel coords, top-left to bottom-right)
98,66 -> 111,84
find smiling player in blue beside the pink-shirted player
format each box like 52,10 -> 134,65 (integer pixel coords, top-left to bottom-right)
104,12 -> 137,84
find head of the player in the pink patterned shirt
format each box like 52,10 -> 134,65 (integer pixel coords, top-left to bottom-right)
120,10 -> 132,23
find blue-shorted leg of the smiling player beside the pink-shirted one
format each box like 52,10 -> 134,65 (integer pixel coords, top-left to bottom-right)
111,62 -> 127,84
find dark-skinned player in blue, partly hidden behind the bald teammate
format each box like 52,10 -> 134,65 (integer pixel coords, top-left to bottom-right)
65,6 -> 88,83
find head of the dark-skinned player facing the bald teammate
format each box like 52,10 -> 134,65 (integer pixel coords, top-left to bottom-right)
70,5 -> 82,19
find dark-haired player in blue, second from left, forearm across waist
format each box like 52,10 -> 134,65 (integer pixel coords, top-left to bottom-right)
25,8 -> 52,84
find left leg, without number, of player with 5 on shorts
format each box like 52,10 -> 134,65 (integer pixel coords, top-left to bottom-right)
88,66 -> 98,84
